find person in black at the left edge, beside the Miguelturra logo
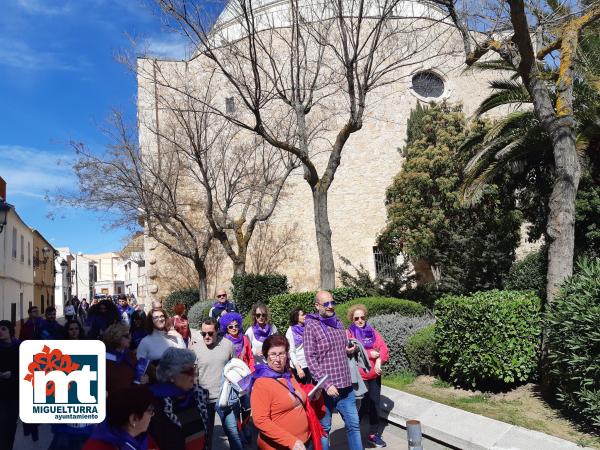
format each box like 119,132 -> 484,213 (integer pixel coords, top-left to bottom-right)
0,320 -> 19,449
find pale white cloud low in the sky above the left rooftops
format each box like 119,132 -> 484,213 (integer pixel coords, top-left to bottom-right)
0,145 -> 75,201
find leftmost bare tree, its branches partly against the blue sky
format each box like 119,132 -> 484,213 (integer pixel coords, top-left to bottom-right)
57,111 -> 213,300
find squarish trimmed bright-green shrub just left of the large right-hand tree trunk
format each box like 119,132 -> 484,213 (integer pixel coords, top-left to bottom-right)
435,290 -> 541,388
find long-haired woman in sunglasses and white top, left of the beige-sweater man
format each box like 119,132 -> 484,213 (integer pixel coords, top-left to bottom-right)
137,308 -> 185,362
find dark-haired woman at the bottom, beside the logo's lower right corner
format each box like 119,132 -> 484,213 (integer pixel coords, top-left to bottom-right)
82,386 -> 155,450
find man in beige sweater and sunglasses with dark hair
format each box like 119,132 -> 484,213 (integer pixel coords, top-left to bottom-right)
190,317 -> 243,450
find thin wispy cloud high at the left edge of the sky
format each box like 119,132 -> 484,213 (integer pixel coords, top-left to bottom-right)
0,37 -> 86,70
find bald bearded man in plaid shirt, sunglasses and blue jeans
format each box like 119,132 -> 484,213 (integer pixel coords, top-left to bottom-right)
304,291 -> 363,450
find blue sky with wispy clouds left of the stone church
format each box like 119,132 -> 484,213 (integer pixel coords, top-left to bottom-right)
0,0 -> 210,253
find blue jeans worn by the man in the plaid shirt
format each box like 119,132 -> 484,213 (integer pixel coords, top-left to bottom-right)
321,386 -> 363,450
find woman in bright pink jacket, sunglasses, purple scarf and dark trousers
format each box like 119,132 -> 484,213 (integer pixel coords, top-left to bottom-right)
347,304 -> 388,447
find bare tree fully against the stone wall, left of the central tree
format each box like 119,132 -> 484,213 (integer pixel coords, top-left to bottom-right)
140,62 -> 299,275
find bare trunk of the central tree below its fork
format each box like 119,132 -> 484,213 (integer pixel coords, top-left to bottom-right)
312,185 -> 335,290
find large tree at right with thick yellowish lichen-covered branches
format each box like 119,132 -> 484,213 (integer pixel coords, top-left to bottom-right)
434,0 -> 600,301
